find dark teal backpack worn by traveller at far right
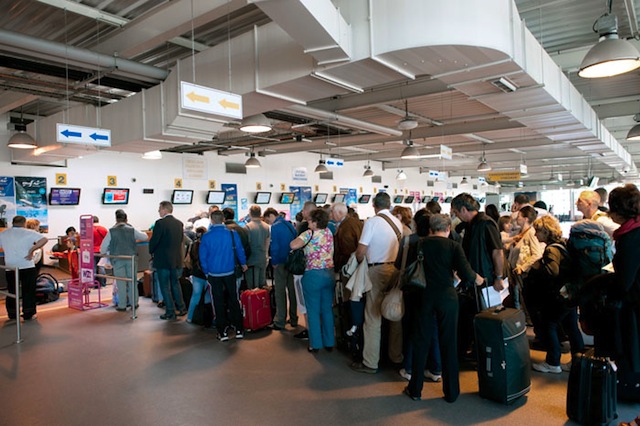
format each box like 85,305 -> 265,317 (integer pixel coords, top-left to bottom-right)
567,219 -> 613,299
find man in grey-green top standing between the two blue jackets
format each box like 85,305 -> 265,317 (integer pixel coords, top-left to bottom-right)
244,205 -> 271,290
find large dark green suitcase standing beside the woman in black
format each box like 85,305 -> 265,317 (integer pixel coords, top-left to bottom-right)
473,306 -> 531,404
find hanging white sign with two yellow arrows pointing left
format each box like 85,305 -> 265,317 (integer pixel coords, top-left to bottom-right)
180,81 -> 242,120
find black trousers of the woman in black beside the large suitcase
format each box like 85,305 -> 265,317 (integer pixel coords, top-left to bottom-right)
409,287 -> 460,402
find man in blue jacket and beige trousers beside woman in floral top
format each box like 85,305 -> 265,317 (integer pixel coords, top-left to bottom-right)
264,207 -> 298,330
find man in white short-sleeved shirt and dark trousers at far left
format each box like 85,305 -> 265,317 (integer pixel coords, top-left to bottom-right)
0,216 -> 47,321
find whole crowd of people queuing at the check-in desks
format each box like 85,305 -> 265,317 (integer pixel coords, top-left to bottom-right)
0,184 -> 640,402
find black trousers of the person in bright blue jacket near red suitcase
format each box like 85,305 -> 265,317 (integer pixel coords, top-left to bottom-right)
207,274 -> 243,333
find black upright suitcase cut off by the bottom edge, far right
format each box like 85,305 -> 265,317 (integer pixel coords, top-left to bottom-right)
567,349 -> 618,425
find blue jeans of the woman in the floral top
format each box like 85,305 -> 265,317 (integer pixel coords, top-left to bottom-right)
302,269 -> 336,349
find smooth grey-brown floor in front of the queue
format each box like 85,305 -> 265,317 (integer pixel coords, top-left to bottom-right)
0,268 -> 640,426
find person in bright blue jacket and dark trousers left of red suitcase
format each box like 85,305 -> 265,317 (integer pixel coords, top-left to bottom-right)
200,210 -> 247,342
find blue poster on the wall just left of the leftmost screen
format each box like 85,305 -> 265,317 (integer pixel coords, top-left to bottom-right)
15,176 -> 49,232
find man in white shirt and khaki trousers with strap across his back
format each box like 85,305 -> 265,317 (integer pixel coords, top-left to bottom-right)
351,192 -> 402,373
